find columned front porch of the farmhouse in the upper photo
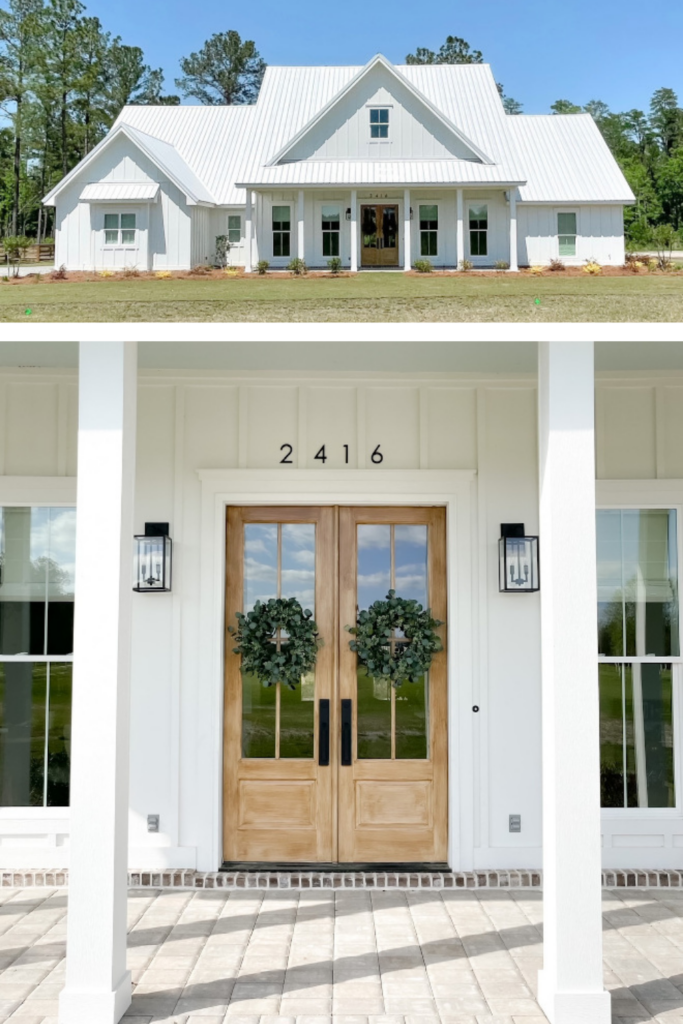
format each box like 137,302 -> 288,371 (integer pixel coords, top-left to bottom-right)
243,185 -> 518,273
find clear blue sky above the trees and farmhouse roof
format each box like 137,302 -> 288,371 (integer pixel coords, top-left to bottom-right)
85,0 -> 683,114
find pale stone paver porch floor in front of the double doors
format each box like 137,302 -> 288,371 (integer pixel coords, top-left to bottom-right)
0,889 -> 683,1024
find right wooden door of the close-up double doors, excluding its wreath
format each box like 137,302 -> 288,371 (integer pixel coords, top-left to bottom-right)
338,508 -> 447,862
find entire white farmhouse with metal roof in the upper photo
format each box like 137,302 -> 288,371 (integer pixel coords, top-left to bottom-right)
44,55 -> 634,271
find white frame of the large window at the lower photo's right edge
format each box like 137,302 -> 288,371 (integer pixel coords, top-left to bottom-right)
596,480 -> 683,823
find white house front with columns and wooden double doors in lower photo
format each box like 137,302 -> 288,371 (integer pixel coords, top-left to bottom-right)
0,341 -> 683,1024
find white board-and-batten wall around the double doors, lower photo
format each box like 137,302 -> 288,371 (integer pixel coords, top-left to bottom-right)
0,371 -> 683,868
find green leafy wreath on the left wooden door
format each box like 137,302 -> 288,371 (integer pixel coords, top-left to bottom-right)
228,597 -> 323,690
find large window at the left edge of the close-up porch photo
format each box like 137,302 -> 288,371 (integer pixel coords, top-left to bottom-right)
0,507 -> 76,807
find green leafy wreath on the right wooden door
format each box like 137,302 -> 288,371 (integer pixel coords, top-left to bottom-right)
346,590 -> 443,687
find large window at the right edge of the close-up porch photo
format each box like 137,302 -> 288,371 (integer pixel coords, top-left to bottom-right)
597,509 -> 680,808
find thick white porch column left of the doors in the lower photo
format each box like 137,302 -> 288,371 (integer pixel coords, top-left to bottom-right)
59,341 -> 137,1024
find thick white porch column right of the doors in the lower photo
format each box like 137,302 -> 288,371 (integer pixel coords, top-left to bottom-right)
539,341 -> 610,1024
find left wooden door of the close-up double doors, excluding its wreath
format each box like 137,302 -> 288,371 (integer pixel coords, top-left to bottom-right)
223,508 -> 337,862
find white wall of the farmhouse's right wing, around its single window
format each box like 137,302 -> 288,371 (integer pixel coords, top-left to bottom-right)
517,204 -> 625,266
